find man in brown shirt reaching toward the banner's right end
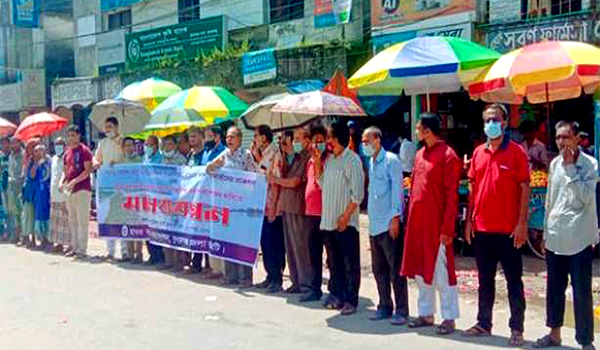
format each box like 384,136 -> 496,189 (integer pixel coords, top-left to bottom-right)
267,128 -> 312,300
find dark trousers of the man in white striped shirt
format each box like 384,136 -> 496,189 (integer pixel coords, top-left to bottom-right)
329,226 -> 360,307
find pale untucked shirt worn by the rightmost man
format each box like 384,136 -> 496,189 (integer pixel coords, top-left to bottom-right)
544,152 -> 599,255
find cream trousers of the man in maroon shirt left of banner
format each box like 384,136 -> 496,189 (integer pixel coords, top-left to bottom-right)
67,190 -> 92,255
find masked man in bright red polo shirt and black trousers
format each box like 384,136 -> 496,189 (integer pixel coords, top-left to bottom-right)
463,104 -> 531,347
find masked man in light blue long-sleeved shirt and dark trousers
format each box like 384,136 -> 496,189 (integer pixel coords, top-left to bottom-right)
362,126 -> 408,326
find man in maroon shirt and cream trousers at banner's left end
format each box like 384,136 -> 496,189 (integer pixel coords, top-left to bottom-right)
59,125 -> 94,258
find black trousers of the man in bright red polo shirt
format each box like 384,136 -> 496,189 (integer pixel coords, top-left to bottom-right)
475,232 -> 525,332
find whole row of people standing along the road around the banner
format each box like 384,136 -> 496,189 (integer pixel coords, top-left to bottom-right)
0,104 -> 598,350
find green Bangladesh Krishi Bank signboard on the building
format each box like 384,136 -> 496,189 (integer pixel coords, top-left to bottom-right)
125,16 -> 227,68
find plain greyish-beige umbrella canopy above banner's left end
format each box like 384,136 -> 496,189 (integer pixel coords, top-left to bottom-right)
90,100 -> 151,134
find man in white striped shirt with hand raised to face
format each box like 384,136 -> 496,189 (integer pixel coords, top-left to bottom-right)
315,122 -> 365,315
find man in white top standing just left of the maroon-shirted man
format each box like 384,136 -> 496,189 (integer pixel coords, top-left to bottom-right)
50,137 -> 71,253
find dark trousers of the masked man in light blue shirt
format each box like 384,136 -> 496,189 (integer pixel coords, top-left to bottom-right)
370,232 -> 408,317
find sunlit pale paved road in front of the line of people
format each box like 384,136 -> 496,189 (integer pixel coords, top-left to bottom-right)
0,245 -> 592,350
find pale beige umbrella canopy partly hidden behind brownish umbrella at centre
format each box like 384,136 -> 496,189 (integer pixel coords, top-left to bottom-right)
242,93 -> 314,132
